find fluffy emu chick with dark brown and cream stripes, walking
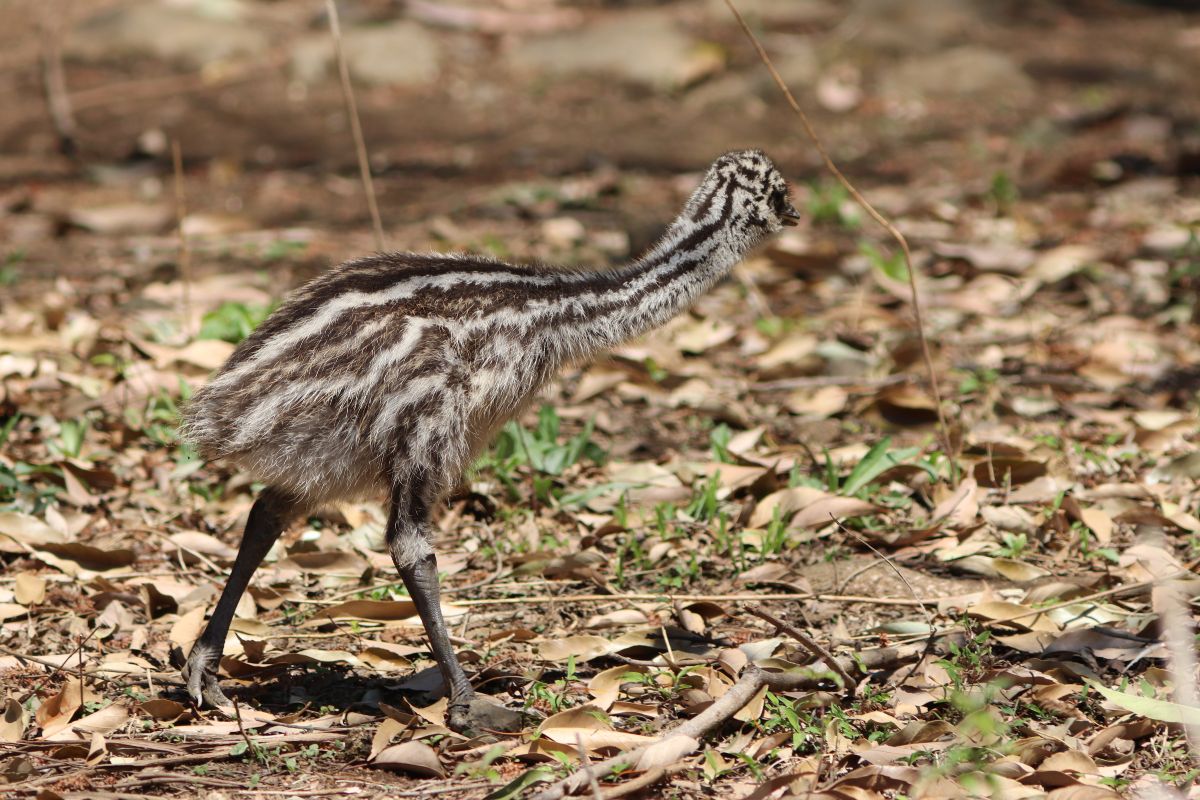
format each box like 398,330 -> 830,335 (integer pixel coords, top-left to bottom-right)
184,150 -> 799,733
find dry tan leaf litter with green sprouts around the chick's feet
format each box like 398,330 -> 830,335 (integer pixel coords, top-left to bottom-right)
0,6 -> 1200,798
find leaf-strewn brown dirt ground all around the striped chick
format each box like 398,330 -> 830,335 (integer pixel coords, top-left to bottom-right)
0,0 -> 1200,799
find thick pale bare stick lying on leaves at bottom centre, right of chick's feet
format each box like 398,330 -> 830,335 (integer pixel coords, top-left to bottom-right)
534,663 -> 810,800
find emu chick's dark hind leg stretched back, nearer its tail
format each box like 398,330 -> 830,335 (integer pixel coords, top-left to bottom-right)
182,487 -> 300,708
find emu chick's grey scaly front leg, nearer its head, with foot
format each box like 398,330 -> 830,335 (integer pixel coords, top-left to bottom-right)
388,503 -> 523,736
